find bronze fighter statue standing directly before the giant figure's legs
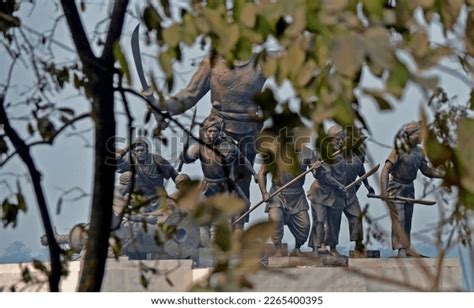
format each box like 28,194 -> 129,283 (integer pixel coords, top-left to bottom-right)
182,115 -> 257,230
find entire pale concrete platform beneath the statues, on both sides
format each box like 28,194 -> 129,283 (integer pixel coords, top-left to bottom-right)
0,257 -> 463,292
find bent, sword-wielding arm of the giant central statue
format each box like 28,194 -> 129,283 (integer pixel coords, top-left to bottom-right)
165,57 -> 211,115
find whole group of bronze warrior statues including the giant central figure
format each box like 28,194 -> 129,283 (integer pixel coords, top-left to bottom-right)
117,52 -> 442,257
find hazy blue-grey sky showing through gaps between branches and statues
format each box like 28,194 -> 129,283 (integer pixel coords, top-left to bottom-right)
0,1 -> 470,262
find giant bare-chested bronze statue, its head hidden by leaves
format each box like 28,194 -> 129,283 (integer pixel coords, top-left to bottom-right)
157,56 -> 265,226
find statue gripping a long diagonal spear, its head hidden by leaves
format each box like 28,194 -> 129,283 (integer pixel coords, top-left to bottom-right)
258,147 -> 316,257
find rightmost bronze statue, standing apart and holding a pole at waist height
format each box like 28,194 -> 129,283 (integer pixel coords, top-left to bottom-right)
380,122 -> 442,257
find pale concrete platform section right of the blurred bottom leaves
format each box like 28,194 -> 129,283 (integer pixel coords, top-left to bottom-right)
250,258 -> 463,292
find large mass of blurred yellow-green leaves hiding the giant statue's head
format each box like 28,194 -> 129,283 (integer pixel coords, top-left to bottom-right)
142,0 -> 474,201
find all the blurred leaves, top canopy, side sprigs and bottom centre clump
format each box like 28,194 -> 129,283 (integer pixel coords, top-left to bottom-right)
0,0 -> 474,291
